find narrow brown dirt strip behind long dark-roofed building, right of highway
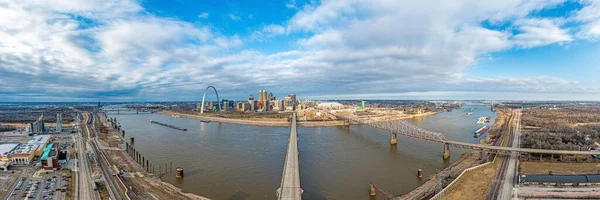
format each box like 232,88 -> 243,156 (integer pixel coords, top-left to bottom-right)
519,162 -> 600,174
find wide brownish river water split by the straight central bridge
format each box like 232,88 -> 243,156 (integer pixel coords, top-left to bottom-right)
109,105 -> 496,199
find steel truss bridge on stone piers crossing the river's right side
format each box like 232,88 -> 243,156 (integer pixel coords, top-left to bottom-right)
330,112 -> 600,159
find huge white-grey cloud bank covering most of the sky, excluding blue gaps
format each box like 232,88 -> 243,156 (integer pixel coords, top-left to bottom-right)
0,0 -> 600,100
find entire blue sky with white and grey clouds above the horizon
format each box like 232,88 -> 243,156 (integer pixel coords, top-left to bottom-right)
0,0 -> 600,102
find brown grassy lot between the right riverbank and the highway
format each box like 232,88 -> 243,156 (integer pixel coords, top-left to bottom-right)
444,162 -> 500,200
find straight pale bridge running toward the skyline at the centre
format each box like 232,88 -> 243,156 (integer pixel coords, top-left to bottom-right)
277,112 -> 302,200
